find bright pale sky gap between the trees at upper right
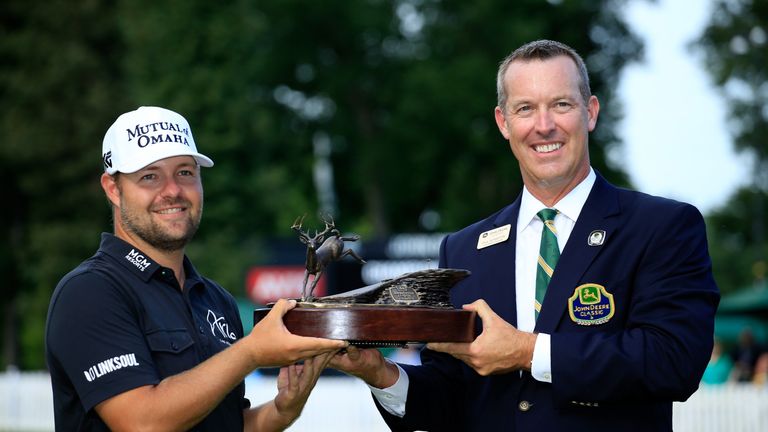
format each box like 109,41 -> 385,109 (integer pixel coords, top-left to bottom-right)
616,0 -> 751,215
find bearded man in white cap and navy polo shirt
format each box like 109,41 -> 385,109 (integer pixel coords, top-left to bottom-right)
46,107 -> 346,431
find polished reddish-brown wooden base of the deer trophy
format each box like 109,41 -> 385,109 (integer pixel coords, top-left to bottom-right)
253,305 -> 476,347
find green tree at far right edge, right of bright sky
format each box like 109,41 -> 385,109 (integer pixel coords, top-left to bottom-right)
693,0 -> 768,291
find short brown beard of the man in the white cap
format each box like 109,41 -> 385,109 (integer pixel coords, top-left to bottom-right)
120,200 -> 203,252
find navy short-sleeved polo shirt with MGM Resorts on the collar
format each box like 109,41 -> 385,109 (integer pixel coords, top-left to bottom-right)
45,233 -> 249,431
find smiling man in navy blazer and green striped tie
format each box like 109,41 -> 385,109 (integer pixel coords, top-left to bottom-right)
332,40 -> 719,431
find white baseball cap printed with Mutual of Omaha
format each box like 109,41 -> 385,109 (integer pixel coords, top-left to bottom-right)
101,106 -> 213,174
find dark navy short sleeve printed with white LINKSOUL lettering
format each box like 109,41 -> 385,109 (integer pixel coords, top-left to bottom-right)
46,272 -> 160,411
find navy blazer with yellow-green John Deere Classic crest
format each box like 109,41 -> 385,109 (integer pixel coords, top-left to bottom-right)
379,174 -> 720,432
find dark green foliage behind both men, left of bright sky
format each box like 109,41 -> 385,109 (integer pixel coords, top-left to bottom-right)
0,0 -> 642,368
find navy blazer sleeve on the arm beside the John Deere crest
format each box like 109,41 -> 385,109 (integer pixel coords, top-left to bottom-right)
551,203 -> 720,405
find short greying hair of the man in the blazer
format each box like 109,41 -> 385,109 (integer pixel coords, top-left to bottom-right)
496,39 -> 592,111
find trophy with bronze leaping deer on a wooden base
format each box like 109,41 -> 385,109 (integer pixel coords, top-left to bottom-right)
254,216 -> 476,347
